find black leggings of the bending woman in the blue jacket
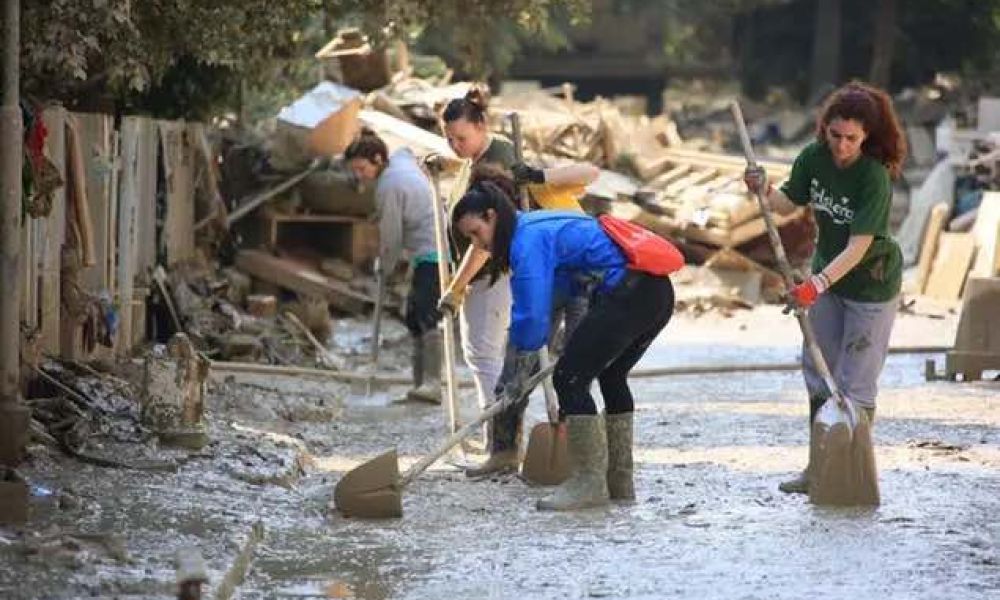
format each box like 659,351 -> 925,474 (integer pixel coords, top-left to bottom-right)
552,271 -> 674,415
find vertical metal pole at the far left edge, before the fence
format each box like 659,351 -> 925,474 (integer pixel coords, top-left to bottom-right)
0,0 -> 29,464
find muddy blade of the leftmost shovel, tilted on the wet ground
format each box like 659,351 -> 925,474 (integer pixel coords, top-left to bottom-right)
333,449 -> 403,519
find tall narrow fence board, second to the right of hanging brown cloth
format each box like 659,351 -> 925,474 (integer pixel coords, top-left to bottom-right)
115,117 -> 148,357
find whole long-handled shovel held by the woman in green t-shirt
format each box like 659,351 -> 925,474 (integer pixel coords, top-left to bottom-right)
732,100 -> 879,506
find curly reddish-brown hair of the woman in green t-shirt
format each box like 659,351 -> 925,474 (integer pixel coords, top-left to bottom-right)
816,81 -> 906,179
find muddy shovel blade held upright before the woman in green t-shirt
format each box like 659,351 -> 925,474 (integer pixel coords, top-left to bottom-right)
809,404 -> 881,506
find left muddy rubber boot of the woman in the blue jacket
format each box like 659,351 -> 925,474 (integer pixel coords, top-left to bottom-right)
538,415 -> 610,510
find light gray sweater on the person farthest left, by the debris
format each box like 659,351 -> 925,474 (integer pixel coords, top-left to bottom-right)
375,148 -> 437,273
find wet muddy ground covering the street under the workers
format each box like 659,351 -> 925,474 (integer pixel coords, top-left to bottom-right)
0,307 -> 1000,599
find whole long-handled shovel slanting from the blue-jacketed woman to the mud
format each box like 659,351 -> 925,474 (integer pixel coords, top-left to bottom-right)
333,365 -> 555,519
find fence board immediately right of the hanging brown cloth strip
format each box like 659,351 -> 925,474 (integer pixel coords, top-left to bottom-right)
73,113 -> 114,293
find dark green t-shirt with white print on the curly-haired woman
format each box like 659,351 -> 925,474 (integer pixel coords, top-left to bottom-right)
781,142 -> 903,302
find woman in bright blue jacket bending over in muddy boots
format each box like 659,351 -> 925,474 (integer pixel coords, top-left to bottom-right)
452,182 -> 674,510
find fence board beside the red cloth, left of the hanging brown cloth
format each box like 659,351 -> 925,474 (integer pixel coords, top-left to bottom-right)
37,106 -> 66,355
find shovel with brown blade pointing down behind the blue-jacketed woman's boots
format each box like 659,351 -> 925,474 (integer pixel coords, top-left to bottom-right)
521,346 -> 569,485
